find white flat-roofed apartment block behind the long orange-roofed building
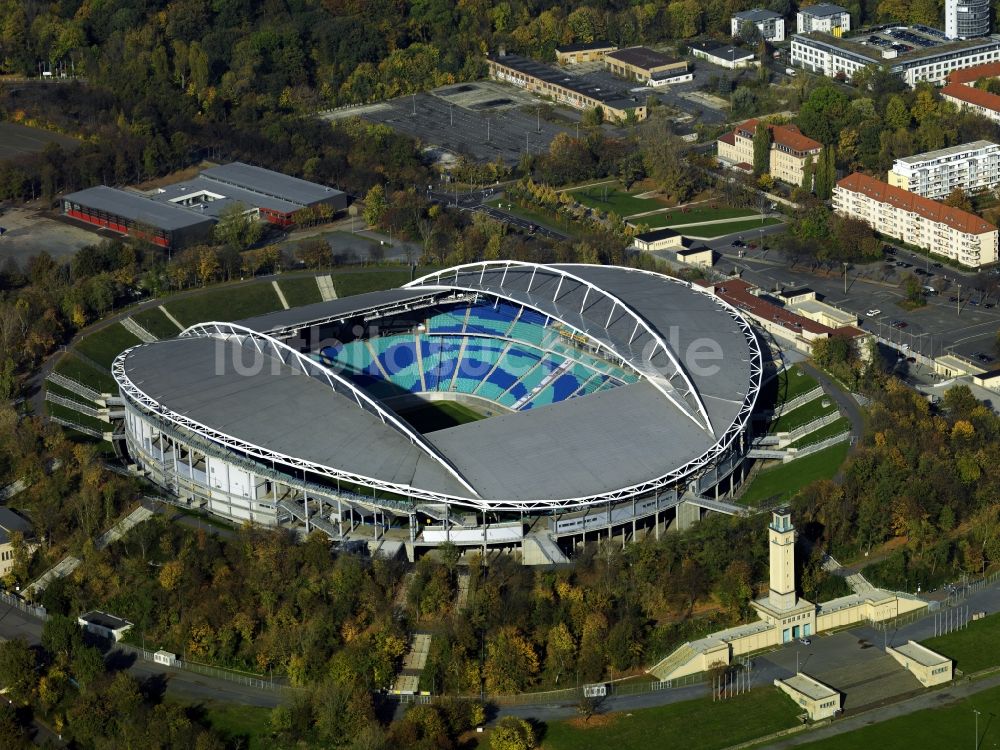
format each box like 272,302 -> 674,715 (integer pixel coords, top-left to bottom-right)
889,141 -> 1000,200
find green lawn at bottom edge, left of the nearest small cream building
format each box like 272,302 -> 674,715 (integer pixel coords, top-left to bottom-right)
542,688 -> 800,750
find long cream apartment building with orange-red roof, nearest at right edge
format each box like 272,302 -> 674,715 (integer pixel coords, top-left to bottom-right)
833,172 -> 997,268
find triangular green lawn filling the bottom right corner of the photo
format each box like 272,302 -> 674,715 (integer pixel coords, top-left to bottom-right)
803,687 -> 1000,750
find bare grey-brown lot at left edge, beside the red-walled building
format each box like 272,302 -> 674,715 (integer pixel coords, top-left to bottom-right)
0,208 -> 97,268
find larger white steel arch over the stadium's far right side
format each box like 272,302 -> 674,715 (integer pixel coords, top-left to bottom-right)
404,260 -> 715,435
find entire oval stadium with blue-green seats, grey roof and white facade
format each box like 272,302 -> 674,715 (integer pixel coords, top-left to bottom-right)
112,261 -> 763,562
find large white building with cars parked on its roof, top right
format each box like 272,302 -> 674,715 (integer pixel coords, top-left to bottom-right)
791,26 -> 1000,87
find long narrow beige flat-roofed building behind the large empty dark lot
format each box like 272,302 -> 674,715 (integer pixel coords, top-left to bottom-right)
487,55 -> 646,122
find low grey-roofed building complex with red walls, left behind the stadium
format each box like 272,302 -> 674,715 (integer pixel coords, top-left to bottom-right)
62,162 -> 347,248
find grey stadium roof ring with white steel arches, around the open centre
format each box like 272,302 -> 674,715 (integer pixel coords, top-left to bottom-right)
113,261 -> 760,509
